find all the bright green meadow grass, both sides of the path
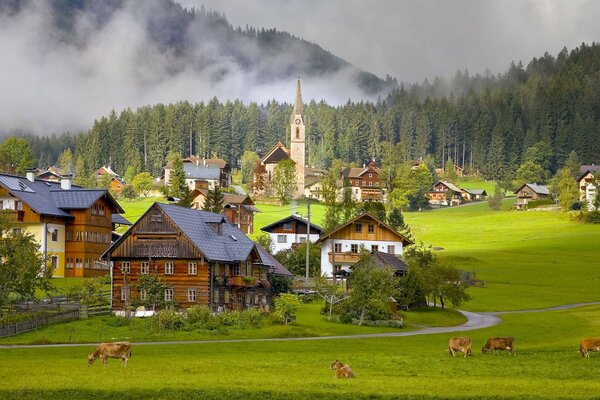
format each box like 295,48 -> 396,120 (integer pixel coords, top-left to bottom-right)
0,186 -> 600,400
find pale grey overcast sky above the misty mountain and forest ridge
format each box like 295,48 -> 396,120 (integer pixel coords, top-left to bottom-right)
180,0 -> 600,82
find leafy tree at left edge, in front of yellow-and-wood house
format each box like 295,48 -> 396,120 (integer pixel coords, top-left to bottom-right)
0,220 -> 52,309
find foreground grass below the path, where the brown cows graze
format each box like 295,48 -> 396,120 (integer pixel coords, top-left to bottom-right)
0,307 -> 600,399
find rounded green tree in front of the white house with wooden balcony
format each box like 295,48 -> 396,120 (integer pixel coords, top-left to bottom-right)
348,253 -> 396,325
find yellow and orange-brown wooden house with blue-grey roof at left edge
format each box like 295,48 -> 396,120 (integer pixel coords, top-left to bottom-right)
0,171 -> 128,277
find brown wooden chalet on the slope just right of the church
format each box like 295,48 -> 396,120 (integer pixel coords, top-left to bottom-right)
340,160 -> 384,202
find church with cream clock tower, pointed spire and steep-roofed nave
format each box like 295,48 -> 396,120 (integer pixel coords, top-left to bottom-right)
252,79 -> 307,198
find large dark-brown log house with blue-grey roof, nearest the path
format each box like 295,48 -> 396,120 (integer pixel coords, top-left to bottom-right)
104,203 -> 291,311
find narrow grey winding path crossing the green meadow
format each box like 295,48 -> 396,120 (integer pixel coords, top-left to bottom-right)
0,301 -> 600,349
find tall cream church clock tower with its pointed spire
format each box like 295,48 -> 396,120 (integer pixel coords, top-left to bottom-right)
290,78 -> 306,197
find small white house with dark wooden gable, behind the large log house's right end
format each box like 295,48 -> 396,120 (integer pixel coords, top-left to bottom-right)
260,214 -> 323,254
